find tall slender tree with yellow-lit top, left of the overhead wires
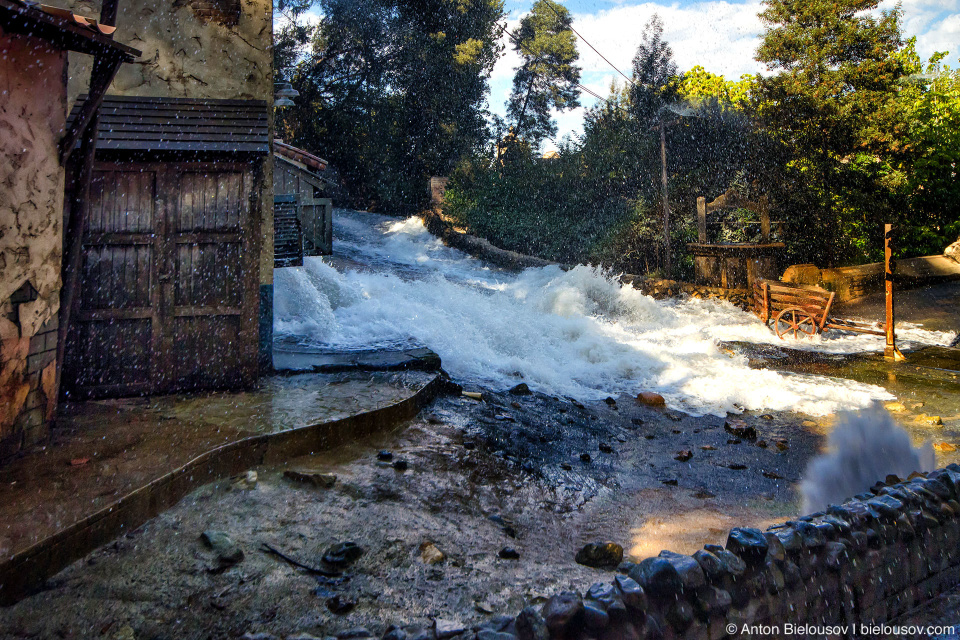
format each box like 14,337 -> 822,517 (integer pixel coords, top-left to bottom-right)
507,0 -> 580,148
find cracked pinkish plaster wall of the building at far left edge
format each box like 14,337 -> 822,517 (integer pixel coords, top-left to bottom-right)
0,31 -> 67,459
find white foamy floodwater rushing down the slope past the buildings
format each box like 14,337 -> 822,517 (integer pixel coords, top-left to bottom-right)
274,210 -> 953,415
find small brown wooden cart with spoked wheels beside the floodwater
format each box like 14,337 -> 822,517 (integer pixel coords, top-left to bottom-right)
753,280 -> 886,339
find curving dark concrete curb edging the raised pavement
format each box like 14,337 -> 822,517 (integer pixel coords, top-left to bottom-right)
0,374 -> 443,606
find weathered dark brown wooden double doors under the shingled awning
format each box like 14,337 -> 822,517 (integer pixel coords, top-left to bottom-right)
63,162 -> 260,397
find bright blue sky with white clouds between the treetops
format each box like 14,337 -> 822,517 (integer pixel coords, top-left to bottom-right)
490,0 -> 960,149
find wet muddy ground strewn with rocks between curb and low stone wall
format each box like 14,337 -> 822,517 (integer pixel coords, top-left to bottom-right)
0,384 -> 822,639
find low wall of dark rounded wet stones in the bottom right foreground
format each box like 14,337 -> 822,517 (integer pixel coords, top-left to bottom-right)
456,465 -> 960,640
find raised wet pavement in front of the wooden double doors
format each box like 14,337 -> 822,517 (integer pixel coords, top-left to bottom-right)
0,371 -> 434,558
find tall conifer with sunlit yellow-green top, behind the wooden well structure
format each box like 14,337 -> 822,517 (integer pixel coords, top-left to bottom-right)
756,0 -> 905,266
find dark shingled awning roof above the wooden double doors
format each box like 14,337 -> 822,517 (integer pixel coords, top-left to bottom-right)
70,96 -> 270,154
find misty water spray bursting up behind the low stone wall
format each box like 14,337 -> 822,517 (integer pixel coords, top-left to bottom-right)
800,403 -> 936,513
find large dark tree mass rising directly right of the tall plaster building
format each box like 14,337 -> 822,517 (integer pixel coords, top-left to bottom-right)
276,0 -> 504,207
